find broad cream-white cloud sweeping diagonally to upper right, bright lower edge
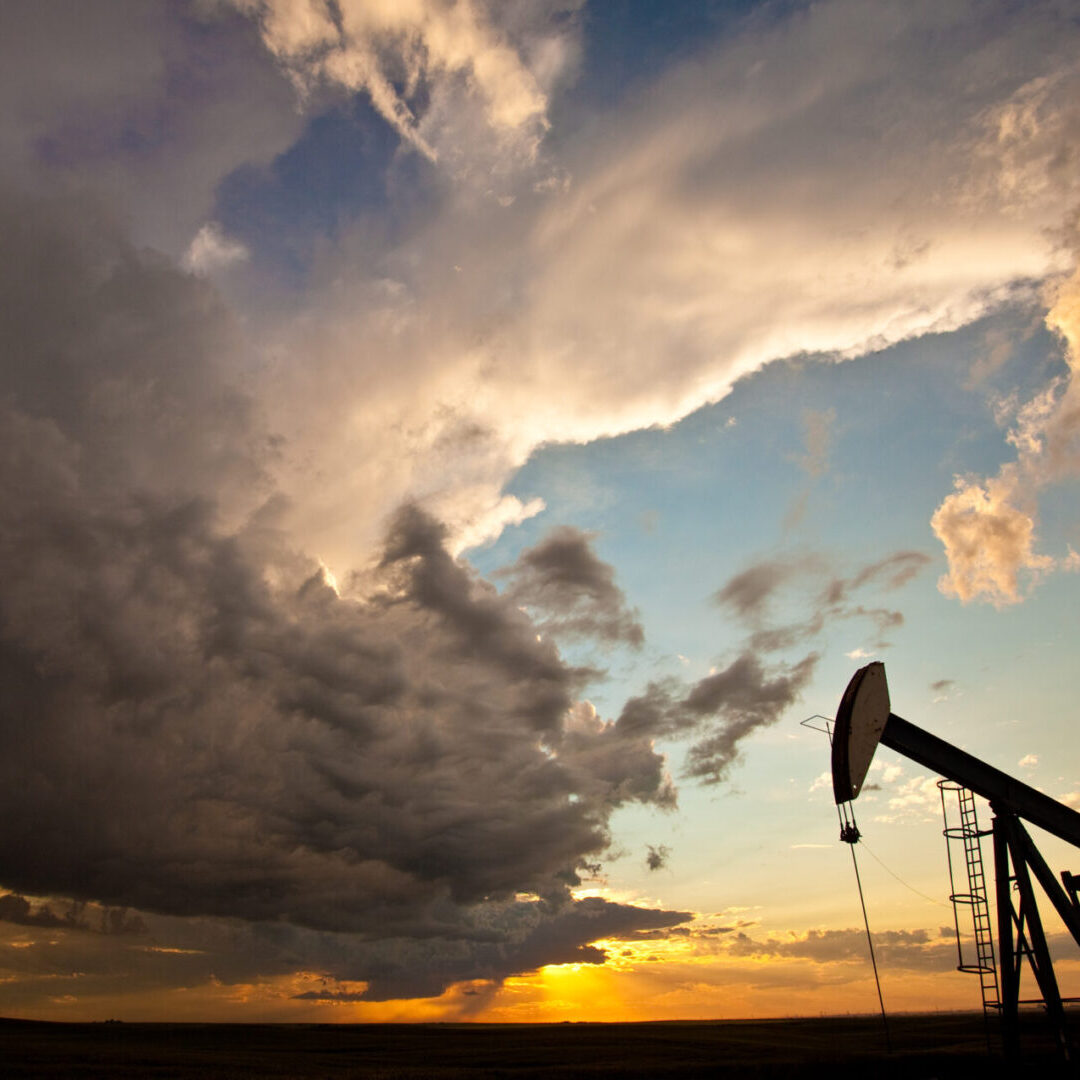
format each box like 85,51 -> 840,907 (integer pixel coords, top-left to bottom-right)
240,0 -> 1077,570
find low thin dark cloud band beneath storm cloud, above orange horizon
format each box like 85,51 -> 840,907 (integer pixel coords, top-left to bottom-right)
0,897 -> 690,1009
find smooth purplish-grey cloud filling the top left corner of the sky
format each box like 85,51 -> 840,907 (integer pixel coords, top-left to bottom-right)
0,0 -> 302,250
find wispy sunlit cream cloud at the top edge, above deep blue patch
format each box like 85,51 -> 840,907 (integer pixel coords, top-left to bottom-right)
232,0 -> 578,183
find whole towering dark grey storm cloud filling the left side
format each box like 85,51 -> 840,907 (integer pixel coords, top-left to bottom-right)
0,190 -> 699,996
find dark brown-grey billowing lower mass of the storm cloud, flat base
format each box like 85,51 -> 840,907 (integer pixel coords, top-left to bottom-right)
0,477 -> 663,935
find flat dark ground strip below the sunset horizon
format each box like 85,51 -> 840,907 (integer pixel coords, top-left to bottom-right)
0,1013 -> 1080,1080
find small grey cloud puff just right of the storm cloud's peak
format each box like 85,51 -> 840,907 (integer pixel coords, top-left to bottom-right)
502,525 -> 645,648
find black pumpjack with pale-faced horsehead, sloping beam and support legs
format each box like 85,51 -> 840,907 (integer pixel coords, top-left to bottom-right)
833,661 -> 1080,1062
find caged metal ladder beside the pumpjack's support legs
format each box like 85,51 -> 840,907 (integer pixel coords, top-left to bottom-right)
937,780 -> 1001,1018
